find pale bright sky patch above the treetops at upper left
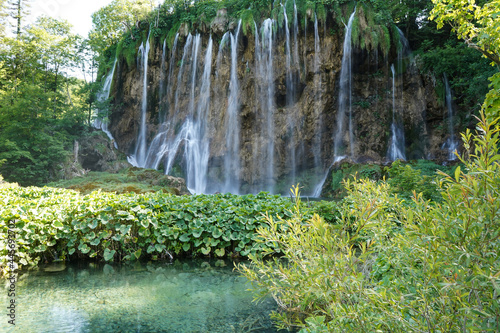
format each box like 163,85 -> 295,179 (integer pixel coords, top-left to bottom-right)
31,0 -> 112,37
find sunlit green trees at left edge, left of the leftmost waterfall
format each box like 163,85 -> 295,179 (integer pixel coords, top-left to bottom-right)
0,17 -> 93,185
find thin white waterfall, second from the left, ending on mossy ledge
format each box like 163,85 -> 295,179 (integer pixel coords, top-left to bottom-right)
129,30 -> 151,168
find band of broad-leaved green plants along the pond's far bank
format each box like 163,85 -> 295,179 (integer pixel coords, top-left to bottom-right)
0,187 -> 318,272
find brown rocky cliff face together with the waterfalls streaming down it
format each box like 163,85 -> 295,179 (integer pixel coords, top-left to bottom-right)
110,7 -> 456,194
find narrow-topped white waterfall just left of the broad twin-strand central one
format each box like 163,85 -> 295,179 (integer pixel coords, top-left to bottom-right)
223,20 -> 241,194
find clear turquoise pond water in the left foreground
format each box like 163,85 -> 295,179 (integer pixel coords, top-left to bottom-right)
0,260 -> 276,333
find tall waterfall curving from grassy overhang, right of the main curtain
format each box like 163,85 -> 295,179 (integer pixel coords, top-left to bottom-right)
333,8 -> 356,158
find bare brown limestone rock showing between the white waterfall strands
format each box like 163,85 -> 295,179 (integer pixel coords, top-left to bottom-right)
109,13 -> 452,192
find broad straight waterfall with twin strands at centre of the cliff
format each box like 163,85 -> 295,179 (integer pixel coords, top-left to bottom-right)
254,19 -> 276,193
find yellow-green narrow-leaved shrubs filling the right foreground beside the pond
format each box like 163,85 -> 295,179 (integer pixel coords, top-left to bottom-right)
238,111 -> 500,332
